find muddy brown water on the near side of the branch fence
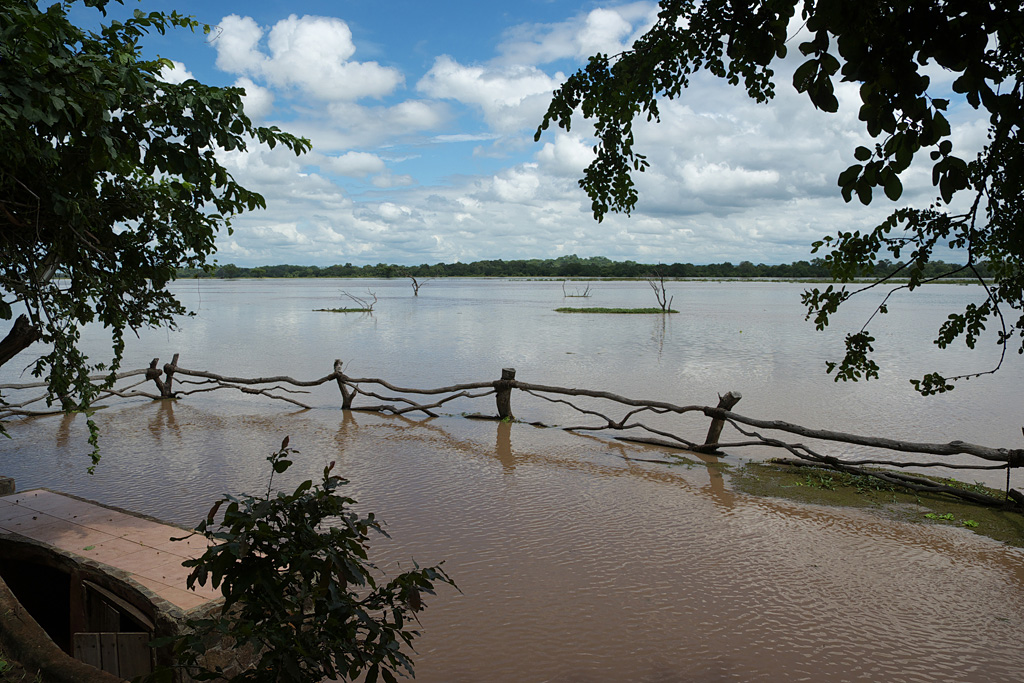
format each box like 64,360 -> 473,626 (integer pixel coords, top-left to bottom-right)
2,405 -> 1024,683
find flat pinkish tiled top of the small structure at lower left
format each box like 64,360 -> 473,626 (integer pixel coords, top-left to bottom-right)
0,488 -> 220,610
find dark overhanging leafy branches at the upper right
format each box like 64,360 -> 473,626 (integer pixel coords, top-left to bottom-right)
537,0 -> 1024,394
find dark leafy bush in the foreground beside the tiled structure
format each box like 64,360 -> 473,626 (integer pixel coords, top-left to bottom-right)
151,437 -> 455,683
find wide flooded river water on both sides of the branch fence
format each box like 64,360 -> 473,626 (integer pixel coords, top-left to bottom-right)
0,280 -> 1024,681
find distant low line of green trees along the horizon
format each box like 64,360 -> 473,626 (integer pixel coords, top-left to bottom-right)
178,254 -> 987,280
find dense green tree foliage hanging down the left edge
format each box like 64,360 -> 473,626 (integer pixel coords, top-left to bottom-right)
0,0 -> 309,454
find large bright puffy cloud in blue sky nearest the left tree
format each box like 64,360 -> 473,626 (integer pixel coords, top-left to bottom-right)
214,14 -> 403,100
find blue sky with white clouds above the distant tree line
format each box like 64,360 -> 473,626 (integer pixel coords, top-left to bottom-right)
73,0 -> 986,266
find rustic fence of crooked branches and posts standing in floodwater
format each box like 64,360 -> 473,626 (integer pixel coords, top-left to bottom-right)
0,354 -> 1024,510
